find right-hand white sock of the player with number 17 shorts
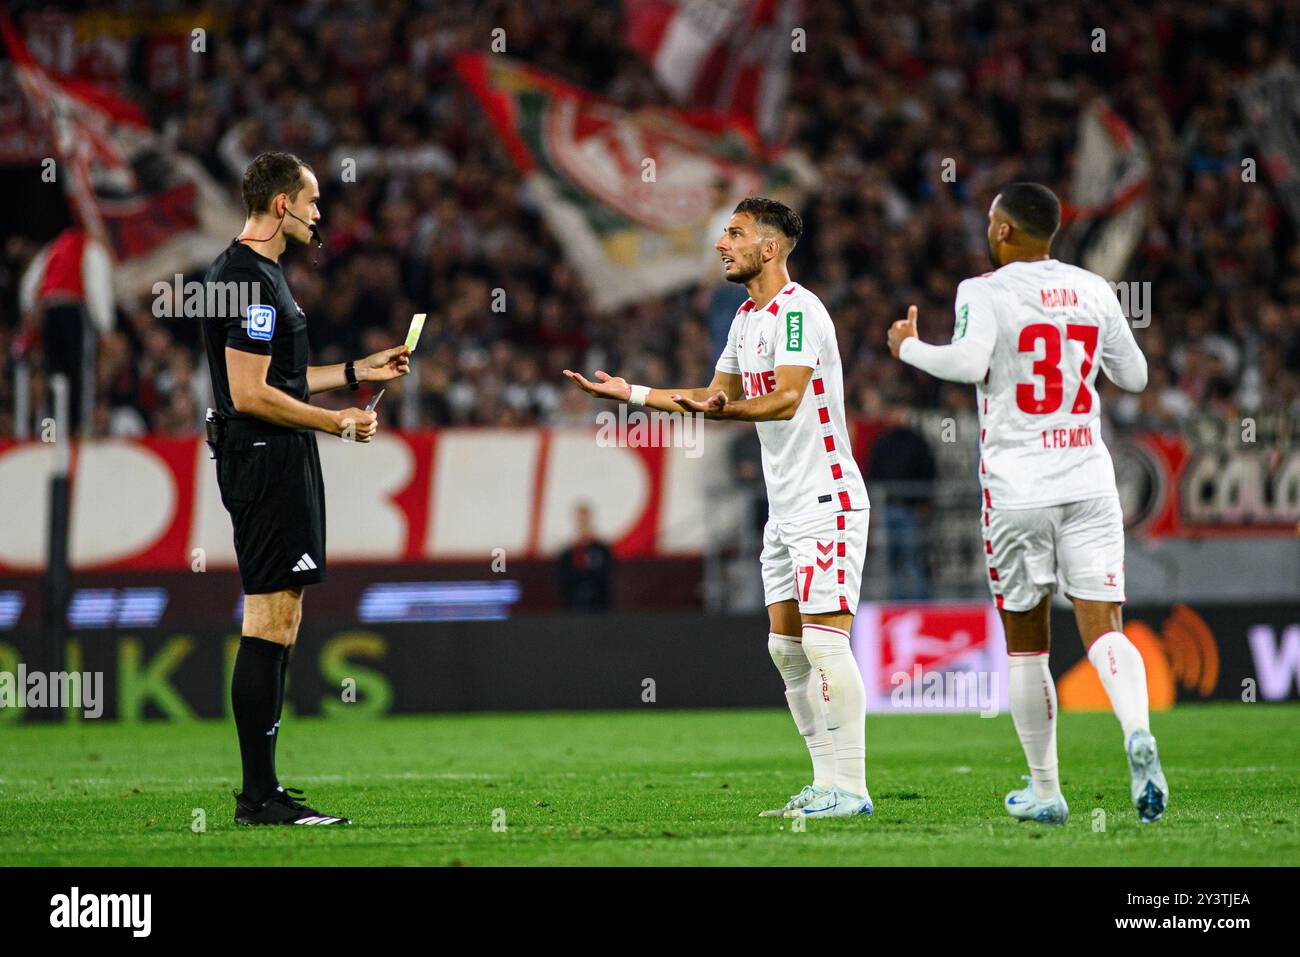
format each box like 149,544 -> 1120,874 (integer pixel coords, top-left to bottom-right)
803,624 -> 867,797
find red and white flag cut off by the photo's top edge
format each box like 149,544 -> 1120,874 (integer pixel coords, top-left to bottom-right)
624,0 -> 802,143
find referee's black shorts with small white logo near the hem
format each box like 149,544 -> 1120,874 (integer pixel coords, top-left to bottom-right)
217,419 -> 325,594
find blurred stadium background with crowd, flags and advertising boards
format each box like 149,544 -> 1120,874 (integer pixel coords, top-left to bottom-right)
0,0 -> 1300,722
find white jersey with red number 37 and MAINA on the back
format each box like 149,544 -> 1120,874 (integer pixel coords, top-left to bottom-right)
900,259 -> 1147,508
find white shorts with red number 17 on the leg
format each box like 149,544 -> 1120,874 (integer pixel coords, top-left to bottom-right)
758,508 -> 871,615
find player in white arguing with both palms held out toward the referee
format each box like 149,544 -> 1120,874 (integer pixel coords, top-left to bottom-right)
564,196 -> 872,817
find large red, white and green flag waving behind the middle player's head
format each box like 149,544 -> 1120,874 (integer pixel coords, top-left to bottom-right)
456,53 -> 813,311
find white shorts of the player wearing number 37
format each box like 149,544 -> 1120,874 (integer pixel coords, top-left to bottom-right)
980,495 -> 1125,611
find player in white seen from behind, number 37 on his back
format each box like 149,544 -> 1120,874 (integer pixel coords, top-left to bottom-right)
889,183 -> 1169,824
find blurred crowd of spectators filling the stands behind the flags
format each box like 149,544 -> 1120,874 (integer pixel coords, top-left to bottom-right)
0,0 -> 1300,434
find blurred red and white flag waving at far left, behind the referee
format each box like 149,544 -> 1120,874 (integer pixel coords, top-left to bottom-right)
0,14 -> 243,295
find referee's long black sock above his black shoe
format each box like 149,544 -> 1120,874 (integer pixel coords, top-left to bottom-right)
230,635 -> 290,801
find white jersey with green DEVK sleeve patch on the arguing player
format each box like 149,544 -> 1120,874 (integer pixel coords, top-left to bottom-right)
718,282 -> 870,519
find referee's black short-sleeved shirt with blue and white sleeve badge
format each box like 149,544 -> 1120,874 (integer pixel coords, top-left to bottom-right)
203,241 -> 311,432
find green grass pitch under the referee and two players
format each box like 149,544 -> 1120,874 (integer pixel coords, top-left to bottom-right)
0,703 -> 1300,866
